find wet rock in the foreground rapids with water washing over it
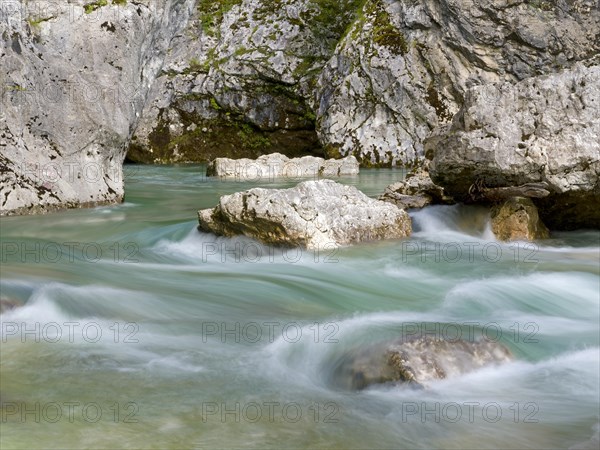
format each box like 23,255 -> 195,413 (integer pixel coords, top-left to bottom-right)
334,336 -> 512,389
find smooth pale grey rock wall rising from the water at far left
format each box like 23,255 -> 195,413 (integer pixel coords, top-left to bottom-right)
0,0 -> 194,215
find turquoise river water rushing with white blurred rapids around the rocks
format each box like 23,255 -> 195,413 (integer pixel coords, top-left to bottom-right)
0,166 -> 600,449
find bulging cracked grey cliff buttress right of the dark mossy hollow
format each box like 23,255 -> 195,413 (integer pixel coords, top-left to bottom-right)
315,0 -> 600,165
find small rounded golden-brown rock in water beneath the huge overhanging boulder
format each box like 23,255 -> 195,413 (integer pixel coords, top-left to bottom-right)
492,197 -> 550,241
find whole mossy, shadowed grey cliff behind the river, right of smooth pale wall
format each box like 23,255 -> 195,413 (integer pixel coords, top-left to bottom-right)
129,0 -> 600,166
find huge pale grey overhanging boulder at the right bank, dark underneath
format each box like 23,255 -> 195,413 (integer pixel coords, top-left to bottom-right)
426,64 -> 600,229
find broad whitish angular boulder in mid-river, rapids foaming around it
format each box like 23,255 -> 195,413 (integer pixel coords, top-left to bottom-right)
198,180 -> 412,249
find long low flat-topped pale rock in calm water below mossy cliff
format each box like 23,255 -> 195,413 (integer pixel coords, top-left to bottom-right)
206,153 -> 359,180
